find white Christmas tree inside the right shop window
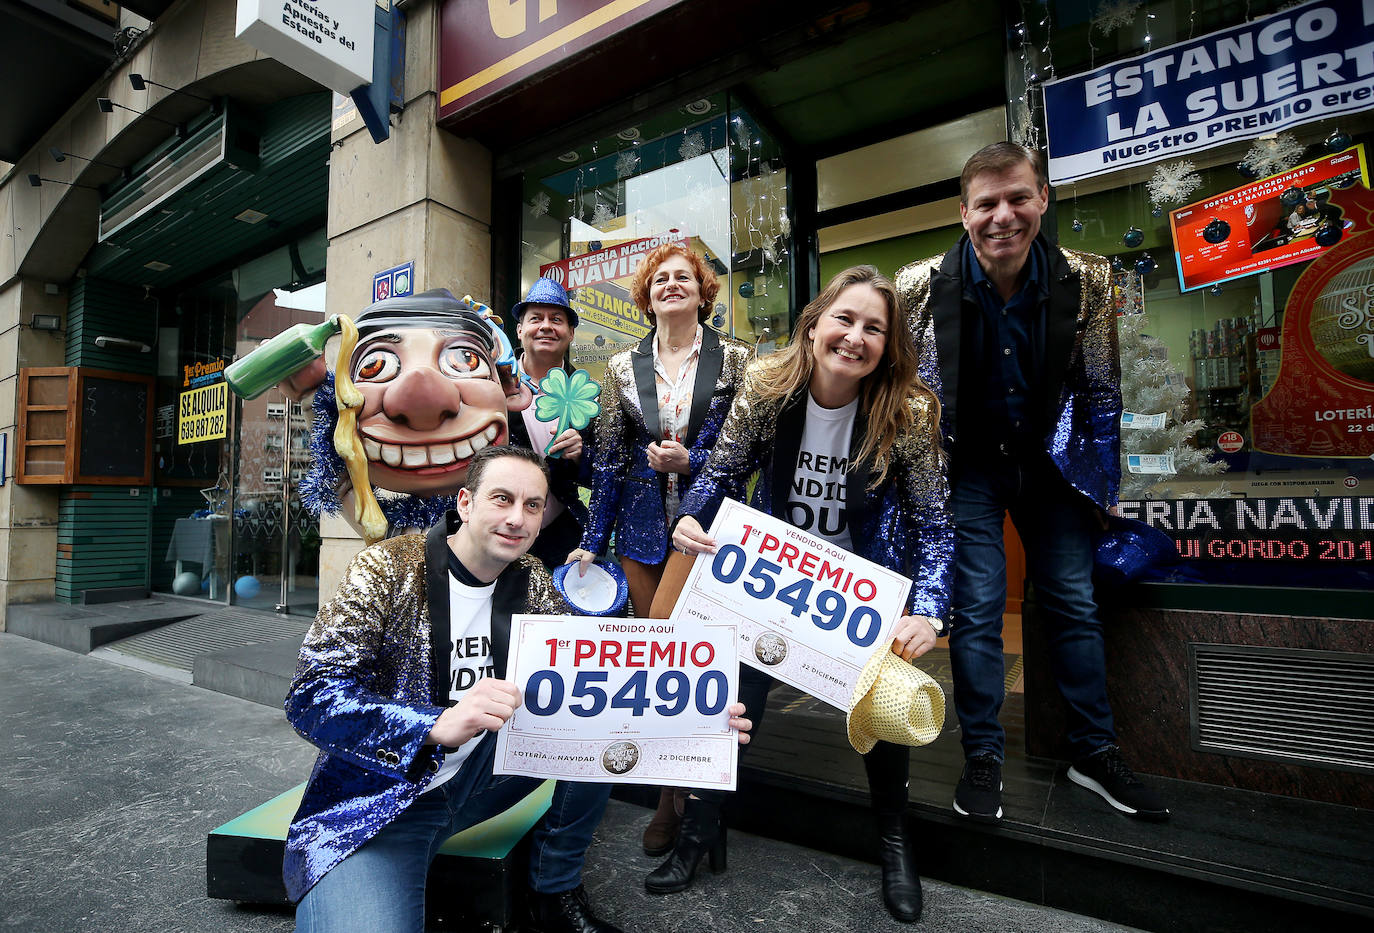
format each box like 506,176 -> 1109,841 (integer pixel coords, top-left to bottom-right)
1117,312 -> 1230,499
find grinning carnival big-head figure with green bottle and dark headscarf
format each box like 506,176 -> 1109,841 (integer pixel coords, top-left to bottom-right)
225,289 -> 530,543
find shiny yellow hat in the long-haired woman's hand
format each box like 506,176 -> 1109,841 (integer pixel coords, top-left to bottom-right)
845,654 -> 944,754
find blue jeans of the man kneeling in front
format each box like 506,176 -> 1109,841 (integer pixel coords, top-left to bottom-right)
295,734 -> 611,933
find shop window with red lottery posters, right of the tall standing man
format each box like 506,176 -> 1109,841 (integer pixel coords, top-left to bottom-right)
1033,3 -> 1374,588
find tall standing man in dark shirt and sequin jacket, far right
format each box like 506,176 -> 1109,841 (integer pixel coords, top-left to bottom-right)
896,143 -> 1168,820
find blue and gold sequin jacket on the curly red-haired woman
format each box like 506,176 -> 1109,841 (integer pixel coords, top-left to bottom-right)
583,327 -> 753,563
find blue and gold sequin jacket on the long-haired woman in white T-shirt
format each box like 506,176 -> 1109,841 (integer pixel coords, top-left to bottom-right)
677,373 -> 954,624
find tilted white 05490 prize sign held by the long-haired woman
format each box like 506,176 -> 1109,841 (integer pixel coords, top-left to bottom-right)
673,499 -> 911,710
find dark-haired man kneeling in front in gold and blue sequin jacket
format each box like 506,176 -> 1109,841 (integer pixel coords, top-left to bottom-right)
283,447 -> 629,933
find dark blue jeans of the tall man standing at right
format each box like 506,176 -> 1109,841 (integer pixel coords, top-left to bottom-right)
949,453 -> 1116,761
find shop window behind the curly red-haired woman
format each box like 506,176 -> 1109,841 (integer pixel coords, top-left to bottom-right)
521,95 -> 791,378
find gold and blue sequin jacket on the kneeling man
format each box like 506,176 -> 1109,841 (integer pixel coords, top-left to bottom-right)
282,513 -> 572,903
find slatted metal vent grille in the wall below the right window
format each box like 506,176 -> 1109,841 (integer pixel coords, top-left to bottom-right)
1190,644 -> 1374,771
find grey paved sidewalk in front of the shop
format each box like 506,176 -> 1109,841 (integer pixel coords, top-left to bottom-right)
0,633 -> 1127,933
